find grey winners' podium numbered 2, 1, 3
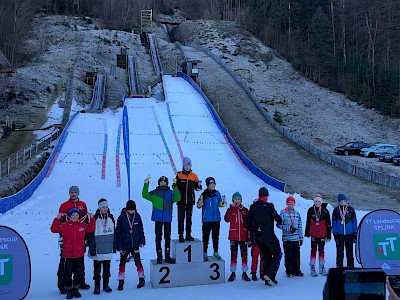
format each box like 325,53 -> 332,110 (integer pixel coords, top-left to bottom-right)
150,239 -> 225,288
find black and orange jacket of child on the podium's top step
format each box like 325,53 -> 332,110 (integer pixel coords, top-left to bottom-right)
176,170 -> 201,206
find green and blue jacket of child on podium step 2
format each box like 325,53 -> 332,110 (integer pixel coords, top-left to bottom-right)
142,183 -> 181,222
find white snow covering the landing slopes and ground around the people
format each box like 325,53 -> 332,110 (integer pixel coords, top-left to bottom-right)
0,76 -> 372,300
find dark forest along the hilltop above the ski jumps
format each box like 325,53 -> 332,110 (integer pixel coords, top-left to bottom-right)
0,0 -> 400,117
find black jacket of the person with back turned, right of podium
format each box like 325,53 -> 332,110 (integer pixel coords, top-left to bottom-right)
247,197 -> 282,244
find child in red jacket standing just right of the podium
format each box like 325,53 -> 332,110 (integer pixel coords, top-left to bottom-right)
224,192 -> 250,282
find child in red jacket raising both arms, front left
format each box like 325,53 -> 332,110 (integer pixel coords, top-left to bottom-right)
51,207 -> 96,299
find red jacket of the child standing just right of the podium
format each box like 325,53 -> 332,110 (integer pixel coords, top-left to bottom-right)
224,204 -> 251,241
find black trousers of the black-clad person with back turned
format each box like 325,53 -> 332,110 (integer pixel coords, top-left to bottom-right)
257,240 -> 282,280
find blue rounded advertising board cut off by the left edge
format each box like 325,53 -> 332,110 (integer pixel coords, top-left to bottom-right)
0,226 -> 31,299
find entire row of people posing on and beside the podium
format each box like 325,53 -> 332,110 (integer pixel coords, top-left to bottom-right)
51,157 -> 357,299
